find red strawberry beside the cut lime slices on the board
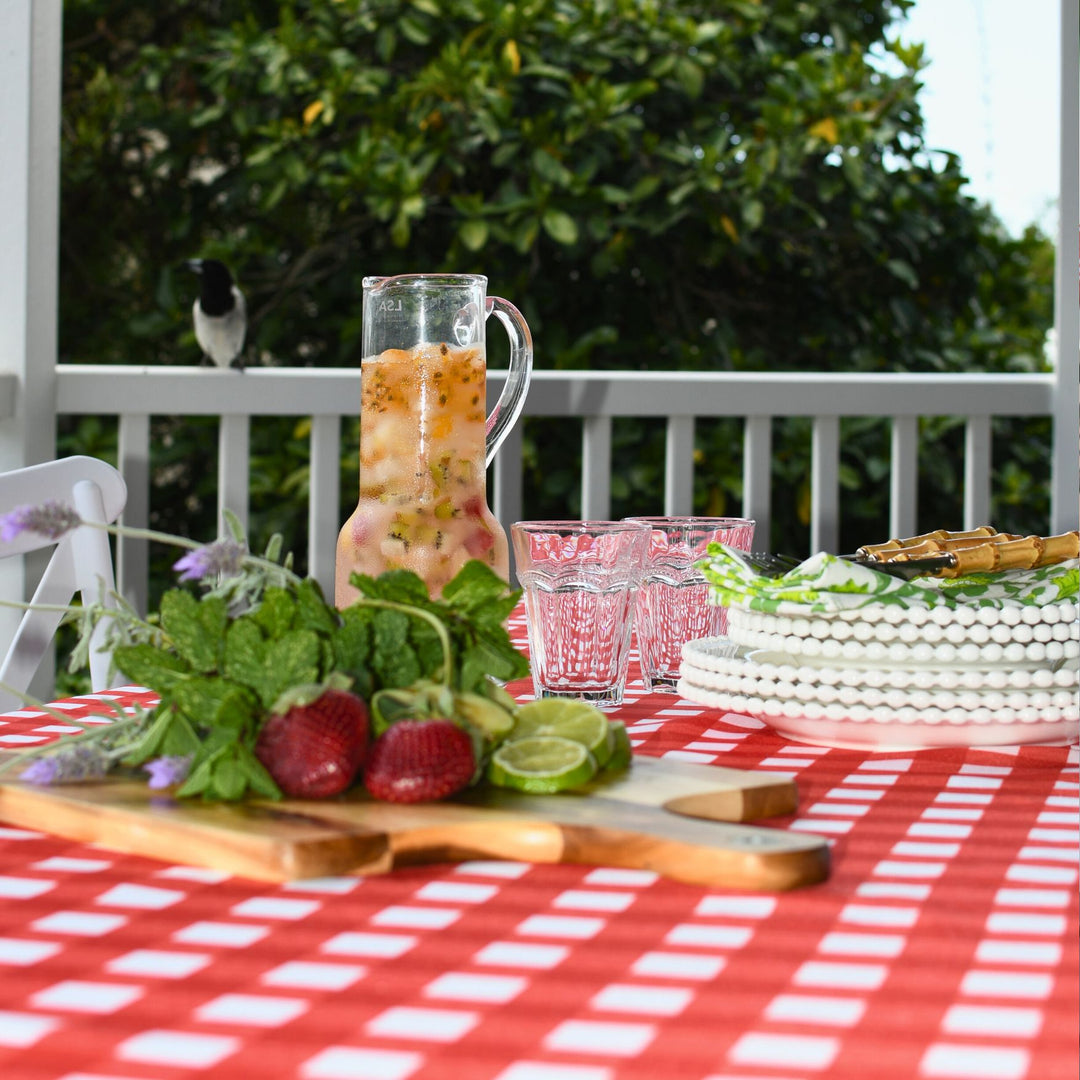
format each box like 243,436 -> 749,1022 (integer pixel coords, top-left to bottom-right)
364,719 -> 476,802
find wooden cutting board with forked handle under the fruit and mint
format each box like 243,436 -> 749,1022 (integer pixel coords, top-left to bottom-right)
0,757 -> 828,890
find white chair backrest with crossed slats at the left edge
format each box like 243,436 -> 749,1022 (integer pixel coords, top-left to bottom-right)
0,456 -> 127,710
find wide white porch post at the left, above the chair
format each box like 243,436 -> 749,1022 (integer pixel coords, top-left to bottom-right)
0,0 -> 63,647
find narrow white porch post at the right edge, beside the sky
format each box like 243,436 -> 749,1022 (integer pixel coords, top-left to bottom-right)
1054,0 -> 1080,532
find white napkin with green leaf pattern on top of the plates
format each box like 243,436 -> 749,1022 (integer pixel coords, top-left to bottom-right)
698,543 -> 1080,615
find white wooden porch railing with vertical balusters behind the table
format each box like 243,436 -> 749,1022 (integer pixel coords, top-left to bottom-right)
27,365 -> 1077,609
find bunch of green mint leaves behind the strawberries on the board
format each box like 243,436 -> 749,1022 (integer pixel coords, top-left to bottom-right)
113,561 -> 529,801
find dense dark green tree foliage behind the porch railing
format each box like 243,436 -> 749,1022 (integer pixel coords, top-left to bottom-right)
60,0 -> 1051,550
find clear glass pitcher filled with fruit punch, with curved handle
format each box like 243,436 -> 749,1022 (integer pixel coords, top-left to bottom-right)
335,274 -> 532,608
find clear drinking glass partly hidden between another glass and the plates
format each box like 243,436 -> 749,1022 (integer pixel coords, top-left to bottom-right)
627,517 -> 754,693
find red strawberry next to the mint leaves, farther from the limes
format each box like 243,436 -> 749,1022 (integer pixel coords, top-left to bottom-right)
255,688 -> 369,799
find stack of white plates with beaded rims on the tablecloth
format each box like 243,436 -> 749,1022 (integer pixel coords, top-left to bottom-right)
678,602 -> 1080,748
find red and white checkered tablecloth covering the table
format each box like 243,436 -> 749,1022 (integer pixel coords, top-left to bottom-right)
0,620 -> 1080,1080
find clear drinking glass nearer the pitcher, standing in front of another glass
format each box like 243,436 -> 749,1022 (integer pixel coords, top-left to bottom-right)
510,521 -> 649,707
